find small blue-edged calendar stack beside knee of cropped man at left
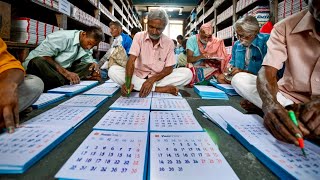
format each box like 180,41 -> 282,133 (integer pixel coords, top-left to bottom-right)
32,93 -> 65,109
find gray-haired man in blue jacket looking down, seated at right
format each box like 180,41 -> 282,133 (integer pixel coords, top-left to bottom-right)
218,16 -> 269,86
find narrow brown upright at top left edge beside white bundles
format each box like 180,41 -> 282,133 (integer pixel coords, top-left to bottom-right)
0,1 -> 11,40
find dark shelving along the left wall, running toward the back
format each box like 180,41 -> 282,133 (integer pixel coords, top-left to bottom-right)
3,0 -> 142,58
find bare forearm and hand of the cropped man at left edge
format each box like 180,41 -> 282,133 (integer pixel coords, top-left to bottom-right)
0,82 -> 19,133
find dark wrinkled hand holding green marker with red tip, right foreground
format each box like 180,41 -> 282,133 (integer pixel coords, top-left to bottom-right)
262,102 -> 309,145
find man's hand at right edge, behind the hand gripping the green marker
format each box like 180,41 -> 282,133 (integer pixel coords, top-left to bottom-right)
299,99 -> 320,136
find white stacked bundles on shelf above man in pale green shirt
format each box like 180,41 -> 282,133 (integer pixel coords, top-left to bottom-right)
11,17 -> 61,44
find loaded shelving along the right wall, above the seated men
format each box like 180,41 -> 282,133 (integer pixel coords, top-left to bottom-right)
185,0 -> 307,48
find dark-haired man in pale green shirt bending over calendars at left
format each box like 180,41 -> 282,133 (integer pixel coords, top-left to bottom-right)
23,26 -> 104,90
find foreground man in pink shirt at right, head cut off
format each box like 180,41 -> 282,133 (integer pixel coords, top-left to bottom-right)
231,0 -> 320,145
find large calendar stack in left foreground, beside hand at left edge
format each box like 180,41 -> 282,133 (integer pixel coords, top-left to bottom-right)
0,106 -> 96,174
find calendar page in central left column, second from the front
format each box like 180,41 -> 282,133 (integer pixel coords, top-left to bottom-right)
93,110 -> 150,131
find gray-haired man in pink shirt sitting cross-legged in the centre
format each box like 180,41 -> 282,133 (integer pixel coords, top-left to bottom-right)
108,9 -> 192,97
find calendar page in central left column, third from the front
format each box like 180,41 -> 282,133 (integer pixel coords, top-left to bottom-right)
109,97 -> 151,110
